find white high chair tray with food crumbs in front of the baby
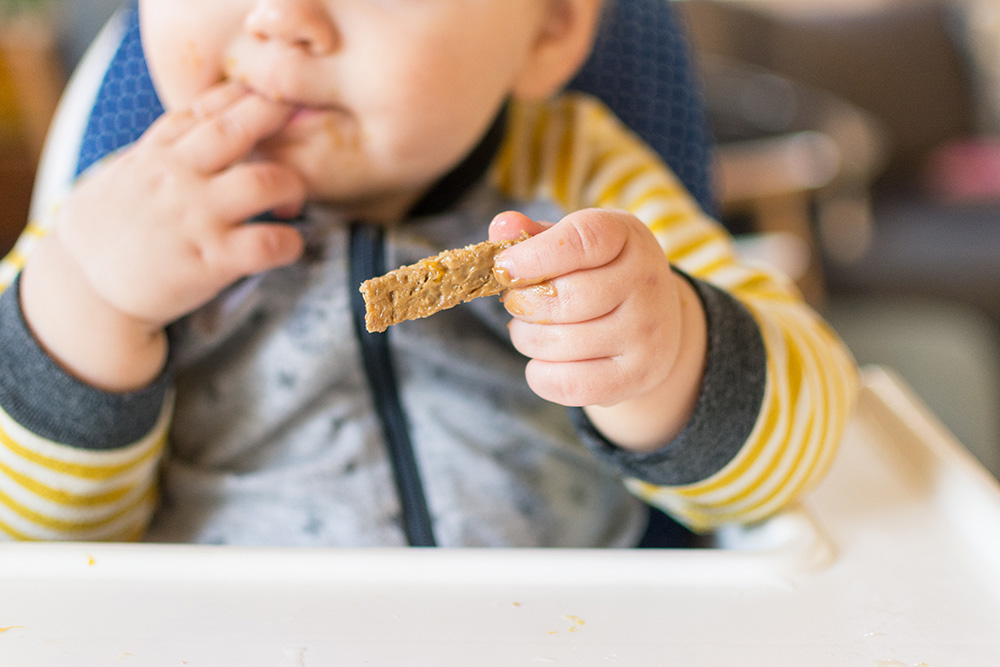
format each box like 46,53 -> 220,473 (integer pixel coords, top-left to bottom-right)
0,369 -> 1000,667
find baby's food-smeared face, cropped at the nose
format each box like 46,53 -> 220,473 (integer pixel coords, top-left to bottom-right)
141,0 -> 560,218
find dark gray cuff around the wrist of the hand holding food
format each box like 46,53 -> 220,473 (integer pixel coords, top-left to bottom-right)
570,274 -> 767,486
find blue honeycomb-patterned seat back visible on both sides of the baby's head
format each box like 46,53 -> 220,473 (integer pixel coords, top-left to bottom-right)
77,0 -> 715,212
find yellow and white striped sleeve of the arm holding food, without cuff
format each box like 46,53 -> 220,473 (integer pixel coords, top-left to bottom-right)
493,94 -> 858,530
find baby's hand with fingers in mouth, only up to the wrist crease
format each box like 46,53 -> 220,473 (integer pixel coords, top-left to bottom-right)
55,83 -> 305,327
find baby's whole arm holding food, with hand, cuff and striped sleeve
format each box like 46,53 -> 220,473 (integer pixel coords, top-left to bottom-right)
494,95 -> 858,529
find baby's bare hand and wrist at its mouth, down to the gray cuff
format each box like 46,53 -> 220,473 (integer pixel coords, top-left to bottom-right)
20,83 -> 305,391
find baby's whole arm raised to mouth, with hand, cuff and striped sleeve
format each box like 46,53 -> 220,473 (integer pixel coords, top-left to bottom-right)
0,84 -> 304,540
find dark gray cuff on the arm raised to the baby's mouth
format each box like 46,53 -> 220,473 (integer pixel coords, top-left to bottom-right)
0,279 -> 170,450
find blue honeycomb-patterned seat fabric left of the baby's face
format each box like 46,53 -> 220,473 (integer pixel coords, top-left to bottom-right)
76,3 -> 163,175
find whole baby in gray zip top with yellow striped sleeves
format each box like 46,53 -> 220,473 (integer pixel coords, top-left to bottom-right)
0,0 -> 856,547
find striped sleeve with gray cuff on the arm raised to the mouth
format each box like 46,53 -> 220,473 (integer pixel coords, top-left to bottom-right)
0,211 -> 171,540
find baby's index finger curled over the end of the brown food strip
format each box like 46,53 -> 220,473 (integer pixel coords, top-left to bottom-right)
496,209 -> 629,286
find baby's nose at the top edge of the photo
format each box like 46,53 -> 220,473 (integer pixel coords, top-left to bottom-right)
245,0 -> 339,56
